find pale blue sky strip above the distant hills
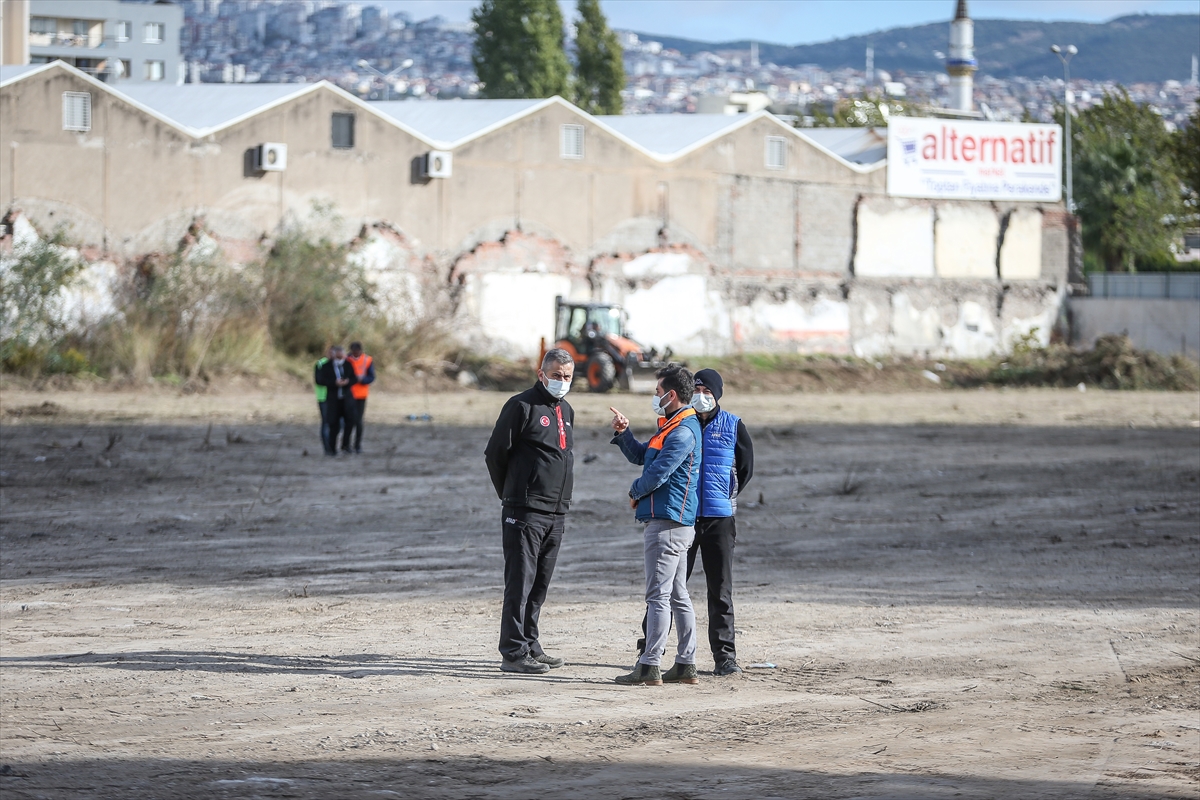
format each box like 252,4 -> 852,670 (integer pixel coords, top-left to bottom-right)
374,0 -> 1200,44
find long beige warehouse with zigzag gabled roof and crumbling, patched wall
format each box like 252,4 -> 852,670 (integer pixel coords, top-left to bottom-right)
0,62 -> 1068,356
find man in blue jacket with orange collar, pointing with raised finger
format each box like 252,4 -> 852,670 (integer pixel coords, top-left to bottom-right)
608,363 -> 701,686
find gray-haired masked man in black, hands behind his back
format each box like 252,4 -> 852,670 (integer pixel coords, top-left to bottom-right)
484,349 -> 575,675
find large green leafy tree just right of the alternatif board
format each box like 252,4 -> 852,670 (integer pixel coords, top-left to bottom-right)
1056,88 -> 1183,272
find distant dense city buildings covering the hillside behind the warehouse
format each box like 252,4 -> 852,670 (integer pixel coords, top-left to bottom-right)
171,0 -> 1200,130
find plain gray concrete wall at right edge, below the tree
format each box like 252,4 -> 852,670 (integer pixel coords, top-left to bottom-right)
1068,297 -> 1200,359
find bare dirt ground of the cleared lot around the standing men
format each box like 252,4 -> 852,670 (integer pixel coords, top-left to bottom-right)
0,390 -> 1200,799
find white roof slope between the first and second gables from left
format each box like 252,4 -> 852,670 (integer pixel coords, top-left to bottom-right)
113,83 -> 316,132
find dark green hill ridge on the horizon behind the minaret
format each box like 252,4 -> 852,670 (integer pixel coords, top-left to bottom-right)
638,14 -> 1200,84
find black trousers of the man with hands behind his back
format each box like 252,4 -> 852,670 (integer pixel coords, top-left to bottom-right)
500,506 -> 565,661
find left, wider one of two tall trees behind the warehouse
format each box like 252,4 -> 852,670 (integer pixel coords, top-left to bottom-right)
470,0 -> 571,98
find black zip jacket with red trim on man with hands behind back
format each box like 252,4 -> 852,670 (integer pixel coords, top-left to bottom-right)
484,381 -> 575,513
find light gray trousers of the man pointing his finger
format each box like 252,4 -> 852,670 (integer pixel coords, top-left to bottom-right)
640,519 -> 696,667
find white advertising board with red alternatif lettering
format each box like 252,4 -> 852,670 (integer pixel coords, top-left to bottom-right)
888,116 -> 1062,203
